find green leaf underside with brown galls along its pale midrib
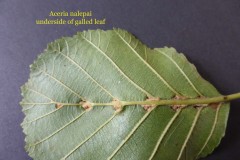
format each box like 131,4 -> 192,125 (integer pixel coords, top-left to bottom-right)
21,29 -> 229,160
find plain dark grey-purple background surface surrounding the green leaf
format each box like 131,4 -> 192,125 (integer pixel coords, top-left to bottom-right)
0,0 -> 240,160
